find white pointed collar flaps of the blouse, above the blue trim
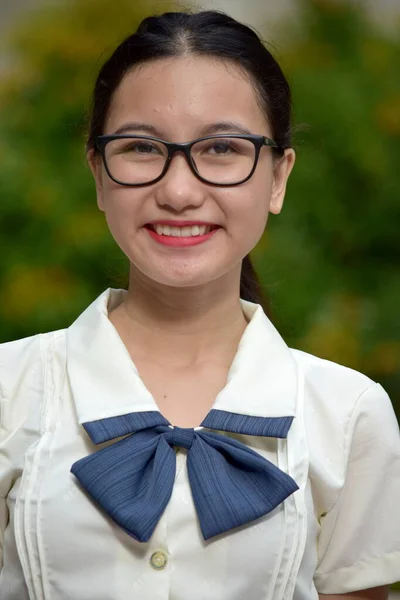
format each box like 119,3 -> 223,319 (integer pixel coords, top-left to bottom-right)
67,288 -> 297,423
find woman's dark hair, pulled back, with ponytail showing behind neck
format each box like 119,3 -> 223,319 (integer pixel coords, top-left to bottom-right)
87,11 -> 291,310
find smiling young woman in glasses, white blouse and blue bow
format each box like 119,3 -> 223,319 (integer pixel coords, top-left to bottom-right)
0,12 -> 400,600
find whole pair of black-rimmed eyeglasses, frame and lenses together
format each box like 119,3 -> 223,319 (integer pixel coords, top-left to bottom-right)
96,133 -> 284,186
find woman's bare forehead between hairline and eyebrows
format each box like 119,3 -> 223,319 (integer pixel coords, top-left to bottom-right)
106,57 -> 269,135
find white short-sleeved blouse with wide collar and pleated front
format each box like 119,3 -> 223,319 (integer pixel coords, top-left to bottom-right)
0,290 -> 400,600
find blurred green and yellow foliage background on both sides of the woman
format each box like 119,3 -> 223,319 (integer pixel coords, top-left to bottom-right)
0,0 -> 400,592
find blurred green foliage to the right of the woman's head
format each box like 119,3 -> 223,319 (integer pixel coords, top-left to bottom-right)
255,0 -> 400,414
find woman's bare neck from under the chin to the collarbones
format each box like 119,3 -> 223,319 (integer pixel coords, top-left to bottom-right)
109,272 -> 247,369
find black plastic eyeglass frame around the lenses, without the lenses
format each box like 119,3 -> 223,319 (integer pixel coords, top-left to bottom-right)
96,133 -> 285,187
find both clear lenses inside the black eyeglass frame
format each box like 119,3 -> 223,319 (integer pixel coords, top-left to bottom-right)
105,137 -> 256,185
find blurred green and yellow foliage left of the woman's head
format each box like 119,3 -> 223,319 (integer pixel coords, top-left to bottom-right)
0,0 -> 173,341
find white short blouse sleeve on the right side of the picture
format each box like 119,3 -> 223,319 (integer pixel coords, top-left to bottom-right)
314,384 -> 400,594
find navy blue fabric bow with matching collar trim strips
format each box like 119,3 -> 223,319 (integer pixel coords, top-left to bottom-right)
71,409 -> 299,542
